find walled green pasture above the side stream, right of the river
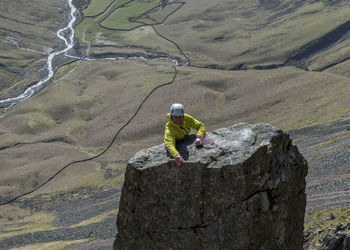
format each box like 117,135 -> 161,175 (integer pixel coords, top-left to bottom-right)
76,0 -> 186,61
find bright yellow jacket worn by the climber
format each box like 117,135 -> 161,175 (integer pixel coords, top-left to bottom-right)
164,113 -> 205,158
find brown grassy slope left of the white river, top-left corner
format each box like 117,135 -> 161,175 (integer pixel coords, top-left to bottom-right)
0,0 -> 66,96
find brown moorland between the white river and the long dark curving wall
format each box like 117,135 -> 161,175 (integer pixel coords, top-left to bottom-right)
0,61 -> 173,199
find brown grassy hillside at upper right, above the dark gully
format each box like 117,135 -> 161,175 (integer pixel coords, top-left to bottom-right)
157,0 -> 350,68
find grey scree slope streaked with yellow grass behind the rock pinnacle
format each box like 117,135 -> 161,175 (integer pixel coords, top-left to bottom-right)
0,120 -> 350,249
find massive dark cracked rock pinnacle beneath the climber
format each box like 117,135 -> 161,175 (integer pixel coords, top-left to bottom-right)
114,124 -> 307,250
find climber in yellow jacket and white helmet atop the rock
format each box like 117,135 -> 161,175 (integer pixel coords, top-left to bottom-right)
164,103 -> 205,166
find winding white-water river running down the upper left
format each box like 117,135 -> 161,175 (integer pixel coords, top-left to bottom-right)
0,0 -> 77,107
